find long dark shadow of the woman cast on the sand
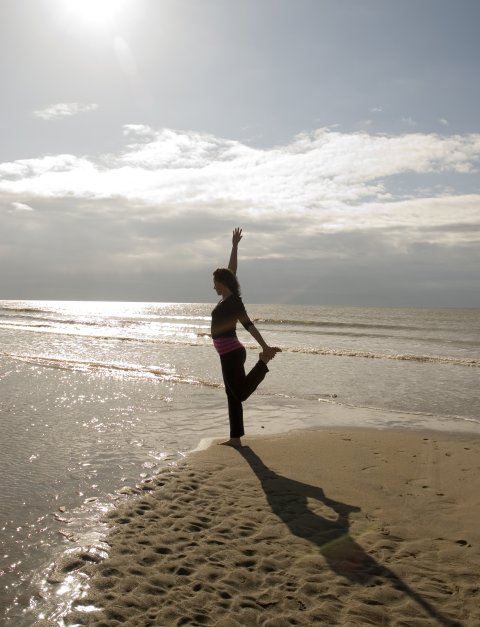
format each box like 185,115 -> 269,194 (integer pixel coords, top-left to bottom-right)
237,446 -> 461,627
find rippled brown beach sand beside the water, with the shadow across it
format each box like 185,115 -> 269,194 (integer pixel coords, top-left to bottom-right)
57,429 -> 480,627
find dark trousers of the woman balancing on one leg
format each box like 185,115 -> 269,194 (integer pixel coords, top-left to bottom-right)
220,346 -> 268,438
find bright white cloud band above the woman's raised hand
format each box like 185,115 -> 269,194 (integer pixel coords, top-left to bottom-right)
0,125 -> 480,213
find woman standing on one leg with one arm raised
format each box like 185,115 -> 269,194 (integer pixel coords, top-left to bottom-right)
211,228 -> 280,446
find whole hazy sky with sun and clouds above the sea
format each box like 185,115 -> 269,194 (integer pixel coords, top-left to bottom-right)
0,0 -> 480,307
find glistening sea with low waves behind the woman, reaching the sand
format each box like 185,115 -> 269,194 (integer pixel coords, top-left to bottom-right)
0,301 -> 480,627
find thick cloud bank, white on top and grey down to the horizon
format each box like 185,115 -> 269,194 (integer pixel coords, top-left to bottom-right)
0,124 -> 480,304
